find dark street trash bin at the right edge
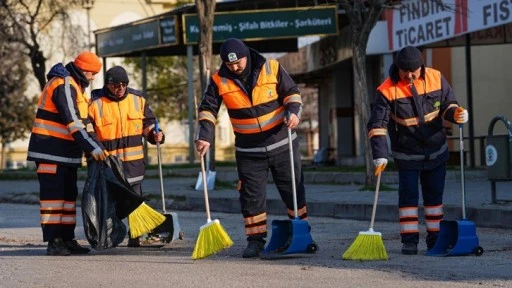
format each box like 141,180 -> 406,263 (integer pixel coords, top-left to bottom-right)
485,115 -> 512,203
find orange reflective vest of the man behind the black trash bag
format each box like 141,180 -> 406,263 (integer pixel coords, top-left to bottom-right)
89,88 -> 155,183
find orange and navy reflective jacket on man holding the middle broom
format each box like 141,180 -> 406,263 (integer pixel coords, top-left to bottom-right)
199,53 -> 302,155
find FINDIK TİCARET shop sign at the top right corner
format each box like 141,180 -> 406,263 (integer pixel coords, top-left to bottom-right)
386,0 -> 512,52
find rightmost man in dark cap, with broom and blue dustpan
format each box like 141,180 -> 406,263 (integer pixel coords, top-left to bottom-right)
367,46 -> 468,255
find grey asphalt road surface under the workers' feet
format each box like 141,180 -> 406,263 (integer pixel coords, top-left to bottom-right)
0,203 -> 512,288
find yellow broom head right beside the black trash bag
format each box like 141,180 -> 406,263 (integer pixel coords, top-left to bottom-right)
128,202 -> 165,238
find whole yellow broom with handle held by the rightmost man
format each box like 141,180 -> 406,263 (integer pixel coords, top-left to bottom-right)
342,171 -> 389,260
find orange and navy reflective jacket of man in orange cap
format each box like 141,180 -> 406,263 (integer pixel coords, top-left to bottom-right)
27,76 -> 99,167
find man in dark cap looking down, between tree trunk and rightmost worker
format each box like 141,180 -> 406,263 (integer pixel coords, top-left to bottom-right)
195,39 -> 308,258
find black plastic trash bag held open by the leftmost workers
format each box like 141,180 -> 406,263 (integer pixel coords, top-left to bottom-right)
82,156 -> 144,250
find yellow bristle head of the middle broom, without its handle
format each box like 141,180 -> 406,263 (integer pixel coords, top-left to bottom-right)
192,219 -> 233,260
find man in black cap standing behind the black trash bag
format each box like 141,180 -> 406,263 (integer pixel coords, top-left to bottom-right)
89,66 -> 165,247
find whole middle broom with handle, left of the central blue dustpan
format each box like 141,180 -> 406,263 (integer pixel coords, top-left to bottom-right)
192,156 -> 233,260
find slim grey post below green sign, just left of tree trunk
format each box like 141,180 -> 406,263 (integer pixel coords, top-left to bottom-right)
187,45 -> 195,164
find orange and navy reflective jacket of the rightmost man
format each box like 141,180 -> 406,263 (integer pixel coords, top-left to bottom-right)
368,65 -> 458,169
